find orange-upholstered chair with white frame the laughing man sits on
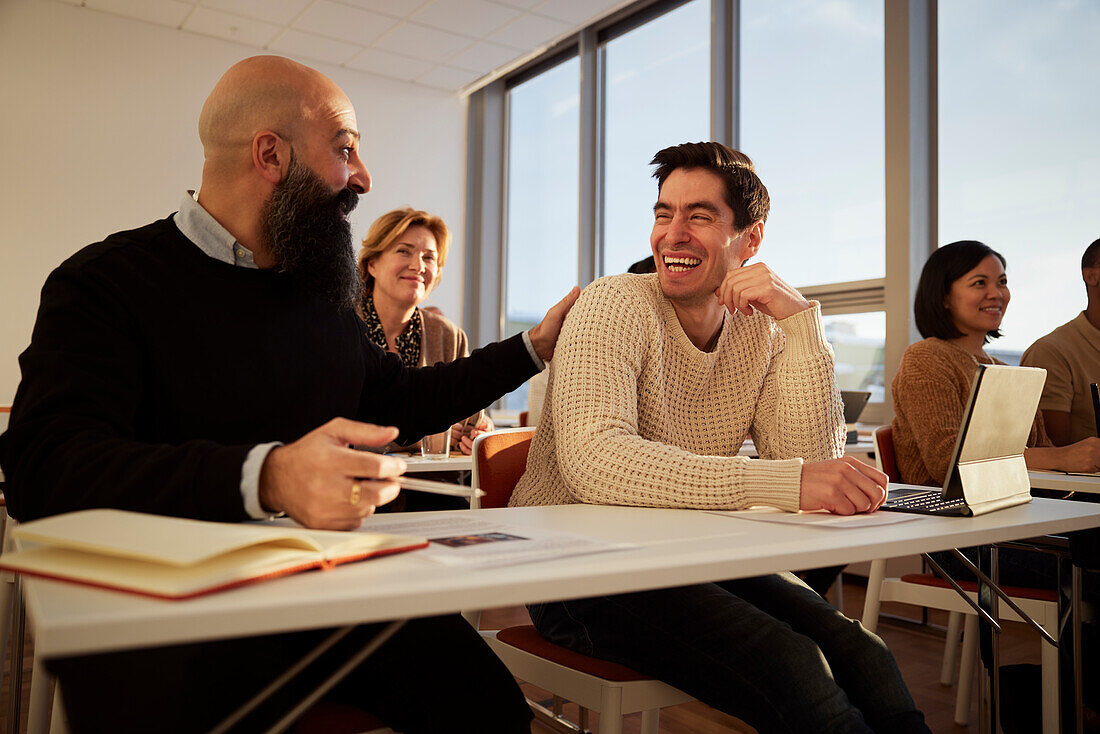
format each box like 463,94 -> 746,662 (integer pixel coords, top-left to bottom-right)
472,428 -> 694,734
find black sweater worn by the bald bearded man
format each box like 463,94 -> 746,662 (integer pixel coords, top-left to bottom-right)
0,218 -> 536,522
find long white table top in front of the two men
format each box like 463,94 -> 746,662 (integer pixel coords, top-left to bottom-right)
19,499 -> 1100,657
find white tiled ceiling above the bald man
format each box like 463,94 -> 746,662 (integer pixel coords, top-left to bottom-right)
53,0 -> 629,92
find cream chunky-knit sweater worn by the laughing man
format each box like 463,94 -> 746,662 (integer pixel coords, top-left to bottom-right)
512,275 -> 844,511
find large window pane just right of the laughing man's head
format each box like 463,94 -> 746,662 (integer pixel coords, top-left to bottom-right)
740,0 -> 884,286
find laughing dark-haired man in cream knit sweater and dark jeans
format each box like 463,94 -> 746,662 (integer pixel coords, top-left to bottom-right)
513,143 -> 928,732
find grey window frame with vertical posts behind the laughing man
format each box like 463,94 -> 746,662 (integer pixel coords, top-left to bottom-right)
463,0 -> 938,423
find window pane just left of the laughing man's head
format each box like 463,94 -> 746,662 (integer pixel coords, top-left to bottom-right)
602,0 -> 711,275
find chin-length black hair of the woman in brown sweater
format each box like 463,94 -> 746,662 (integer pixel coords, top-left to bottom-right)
913,240 -> 1007,343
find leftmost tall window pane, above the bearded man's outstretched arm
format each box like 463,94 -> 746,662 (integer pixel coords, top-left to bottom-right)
504,57 -> 581,410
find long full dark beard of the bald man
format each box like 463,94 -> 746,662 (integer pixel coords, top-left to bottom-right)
261,153 -> 360,308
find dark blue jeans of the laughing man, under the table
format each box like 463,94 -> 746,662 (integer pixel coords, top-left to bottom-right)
528,573 -> 928,734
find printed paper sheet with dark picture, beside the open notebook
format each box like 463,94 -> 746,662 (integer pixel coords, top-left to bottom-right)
362,513 -> 637,568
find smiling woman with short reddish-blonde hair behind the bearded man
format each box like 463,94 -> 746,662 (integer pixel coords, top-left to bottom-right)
355,208 -> 493,454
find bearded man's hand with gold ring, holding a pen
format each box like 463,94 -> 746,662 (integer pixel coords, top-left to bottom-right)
260,418 -> 405,530
